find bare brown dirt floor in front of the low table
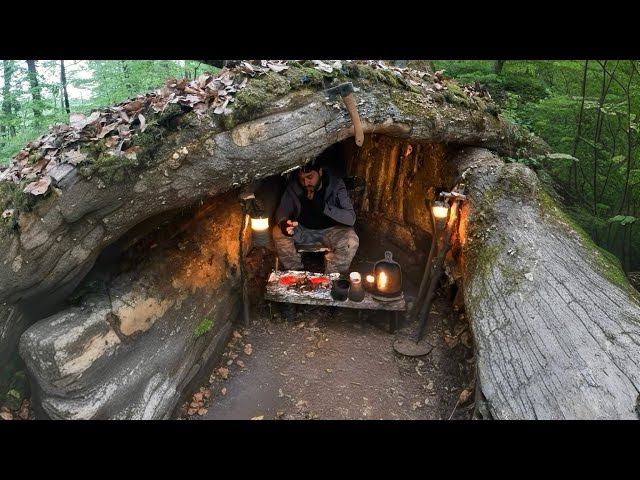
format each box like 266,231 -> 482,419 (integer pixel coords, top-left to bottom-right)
181,284 -> 475,420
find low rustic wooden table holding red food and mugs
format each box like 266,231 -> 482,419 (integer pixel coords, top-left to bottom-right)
264,270 -> 407,333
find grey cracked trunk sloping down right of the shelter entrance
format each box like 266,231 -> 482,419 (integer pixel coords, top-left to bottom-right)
454,149 -> 640,419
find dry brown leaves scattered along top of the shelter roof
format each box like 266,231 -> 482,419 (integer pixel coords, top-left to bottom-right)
0,60 -> 490,201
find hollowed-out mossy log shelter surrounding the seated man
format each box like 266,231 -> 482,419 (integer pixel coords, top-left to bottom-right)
0,61 -> 640,419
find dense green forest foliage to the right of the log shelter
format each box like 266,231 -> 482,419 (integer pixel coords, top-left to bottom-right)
434,60 -> 640,270
